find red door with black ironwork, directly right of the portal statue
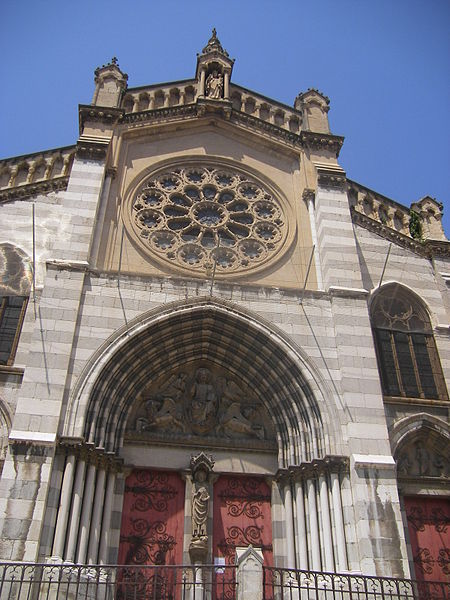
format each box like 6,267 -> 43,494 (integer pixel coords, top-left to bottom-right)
213,475 -> 273,599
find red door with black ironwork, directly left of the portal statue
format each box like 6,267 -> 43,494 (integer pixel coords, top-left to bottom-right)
118,469 -> 184,599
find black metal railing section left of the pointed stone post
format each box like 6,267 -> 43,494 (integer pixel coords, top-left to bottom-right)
0,563 -> 237,600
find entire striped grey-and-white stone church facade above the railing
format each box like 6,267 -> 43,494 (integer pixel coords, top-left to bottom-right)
0,31 -> 450,596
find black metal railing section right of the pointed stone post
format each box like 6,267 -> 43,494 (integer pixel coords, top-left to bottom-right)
263,567 -> 450,600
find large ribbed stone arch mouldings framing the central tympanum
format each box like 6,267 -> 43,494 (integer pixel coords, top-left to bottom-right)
64,299 -> 338,468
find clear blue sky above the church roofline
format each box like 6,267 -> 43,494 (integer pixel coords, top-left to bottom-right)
0,0 -> 450,237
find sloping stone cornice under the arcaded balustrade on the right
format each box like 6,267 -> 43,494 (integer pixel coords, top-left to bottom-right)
350,206 -> 450,258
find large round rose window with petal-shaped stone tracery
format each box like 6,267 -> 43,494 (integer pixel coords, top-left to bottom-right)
132,166 -> 287,274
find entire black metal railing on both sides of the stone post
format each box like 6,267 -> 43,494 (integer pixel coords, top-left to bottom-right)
0,562 -> 450,600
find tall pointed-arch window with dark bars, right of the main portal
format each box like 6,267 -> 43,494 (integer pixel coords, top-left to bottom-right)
371,285 -> 448,400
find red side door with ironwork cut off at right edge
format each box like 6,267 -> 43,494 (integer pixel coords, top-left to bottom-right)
404,496 -> 450,582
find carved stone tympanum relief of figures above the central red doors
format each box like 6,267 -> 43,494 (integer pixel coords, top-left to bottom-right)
128,366 -> 274,445
